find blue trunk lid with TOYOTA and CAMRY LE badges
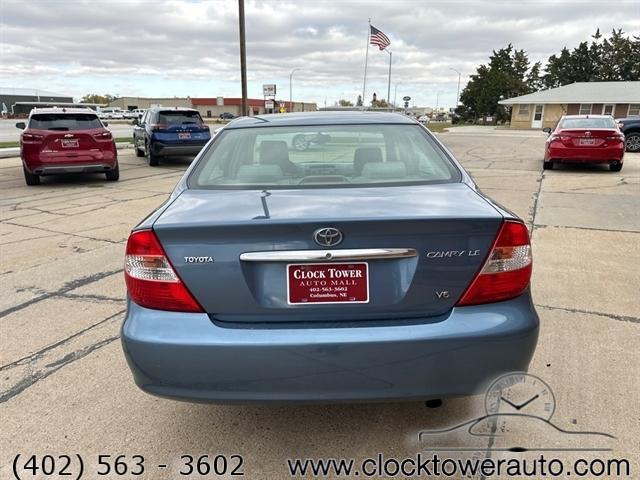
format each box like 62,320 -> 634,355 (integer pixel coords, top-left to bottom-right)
153,183 -> 503,322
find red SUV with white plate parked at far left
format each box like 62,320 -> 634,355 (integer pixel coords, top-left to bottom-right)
16,108 -> 120,185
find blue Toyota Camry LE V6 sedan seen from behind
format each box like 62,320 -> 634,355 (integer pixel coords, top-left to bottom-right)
122,112 -> 538,403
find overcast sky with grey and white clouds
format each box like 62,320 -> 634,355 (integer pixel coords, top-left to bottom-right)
0,0 -> 640,107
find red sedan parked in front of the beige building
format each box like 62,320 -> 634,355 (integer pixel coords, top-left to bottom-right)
543,115 -> 625,172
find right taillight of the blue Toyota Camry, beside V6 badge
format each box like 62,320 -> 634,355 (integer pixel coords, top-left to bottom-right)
458,220 -> 531,306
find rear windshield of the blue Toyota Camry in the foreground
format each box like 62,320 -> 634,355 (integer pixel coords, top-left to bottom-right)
189,125 -> 460,189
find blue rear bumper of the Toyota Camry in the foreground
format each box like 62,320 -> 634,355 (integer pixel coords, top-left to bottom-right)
122,293 -> 538,403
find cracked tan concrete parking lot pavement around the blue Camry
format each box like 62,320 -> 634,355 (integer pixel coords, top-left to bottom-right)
0,129 -> 640,479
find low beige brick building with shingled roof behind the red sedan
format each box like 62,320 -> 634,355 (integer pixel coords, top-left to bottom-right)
498,81 -> 640,129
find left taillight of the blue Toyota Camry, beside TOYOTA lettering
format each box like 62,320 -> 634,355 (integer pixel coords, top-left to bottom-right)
124,230 -> 203,312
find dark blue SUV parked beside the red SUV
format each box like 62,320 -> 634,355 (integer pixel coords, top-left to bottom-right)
133,107 -> 211,167
